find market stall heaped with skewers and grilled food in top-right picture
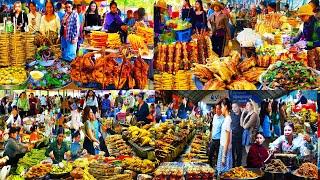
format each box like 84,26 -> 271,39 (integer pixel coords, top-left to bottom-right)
154,1 -> 320,90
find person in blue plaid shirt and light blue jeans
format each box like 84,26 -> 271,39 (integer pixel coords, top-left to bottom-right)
60,1 -> 80,62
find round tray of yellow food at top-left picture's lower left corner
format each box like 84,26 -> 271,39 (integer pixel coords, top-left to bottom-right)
0,66 -> 27,85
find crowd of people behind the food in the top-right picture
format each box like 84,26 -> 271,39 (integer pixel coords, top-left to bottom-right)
154,0 -> 320,56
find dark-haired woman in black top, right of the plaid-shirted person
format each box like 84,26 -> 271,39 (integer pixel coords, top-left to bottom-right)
84,1 -> 101,27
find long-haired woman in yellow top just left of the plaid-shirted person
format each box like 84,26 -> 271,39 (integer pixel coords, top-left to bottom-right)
40,1 -> 61,35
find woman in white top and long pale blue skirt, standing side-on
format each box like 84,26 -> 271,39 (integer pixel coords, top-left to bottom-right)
217,98 -> 232,175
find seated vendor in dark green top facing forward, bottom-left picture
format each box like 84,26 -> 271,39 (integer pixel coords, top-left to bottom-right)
45,130 -> 70,164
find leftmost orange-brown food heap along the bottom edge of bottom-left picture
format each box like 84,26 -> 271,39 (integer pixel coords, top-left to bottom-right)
25,164 -> 52,179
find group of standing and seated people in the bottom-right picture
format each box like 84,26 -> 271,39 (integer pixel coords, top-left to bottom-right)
207,94 -> 317,175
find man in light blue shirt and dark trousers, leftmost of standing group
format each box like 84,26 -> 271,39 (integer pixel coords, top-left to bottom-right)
209,104 -> 224,167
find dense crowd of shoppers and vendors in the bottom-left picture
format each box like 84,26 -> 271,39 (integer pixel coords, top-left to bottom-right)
0,90 -> 158,165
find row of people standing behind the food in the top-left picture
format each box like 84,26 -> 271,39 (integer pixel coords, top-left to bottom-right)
0,0 -> 147,61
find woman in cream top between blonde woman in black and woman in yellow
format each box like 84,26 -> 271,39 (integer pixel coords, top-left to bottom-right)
27,2 -> 41,32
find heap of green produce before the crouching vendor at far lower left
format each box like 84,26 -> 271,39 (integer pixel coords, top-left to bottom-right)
16,149 -> 46,174
